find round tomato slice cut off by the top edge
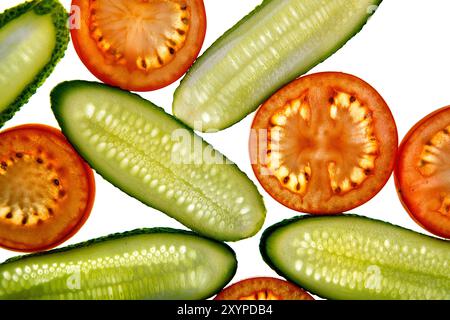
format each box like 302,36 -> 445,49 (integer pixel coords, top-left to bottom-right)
71,0 -> 206,91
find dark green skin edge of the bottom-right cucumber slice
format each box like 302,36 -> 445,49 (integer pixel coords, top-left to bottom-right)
259,214 -> 450,300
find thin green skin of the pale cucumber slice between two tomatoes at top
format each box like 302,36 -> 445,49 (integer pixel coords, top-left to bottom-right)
172,0 -> 383,132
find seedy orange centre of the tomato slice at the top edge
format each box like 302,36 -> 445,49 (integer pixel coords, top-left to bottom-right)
89,0 -> 191,72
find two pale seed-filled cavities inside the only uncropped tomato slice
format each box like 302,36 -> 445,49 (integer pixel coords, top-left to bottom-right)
267,92 -> 380,195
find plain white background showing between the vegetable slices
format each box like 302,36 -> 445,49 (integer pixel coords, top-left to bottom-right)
0,0 -> 450,298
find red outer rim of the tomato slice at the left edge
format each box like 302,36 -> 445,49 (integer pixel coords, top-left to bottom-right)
0,124 -> 96,253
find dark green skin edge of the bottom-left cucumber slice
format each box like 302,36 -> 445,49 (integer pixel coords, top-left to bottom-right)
0,227 -> 238,300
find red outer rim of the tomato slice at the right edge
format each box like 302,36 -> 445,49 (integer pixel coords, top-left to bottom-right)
394,106 -> 450,239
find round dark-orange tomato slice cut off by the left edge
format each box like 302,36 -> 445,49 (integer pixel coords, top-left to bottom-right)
0,124 -> 95,252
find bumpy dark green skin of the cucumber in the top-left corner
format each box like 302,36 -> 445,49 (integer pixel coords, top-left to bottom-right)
0,0 -> 69,128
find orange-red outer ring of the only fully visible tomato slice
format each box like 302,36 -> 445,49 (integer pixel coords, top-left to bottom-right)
249,72 -> 398,215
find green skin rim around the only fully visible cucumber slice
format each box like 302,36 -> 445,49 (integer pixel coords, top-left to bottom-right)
50,80 -> 267,242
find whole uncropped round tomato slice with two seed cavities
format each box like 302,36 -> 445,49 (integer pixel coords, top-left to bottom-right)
250,72 -> 398,214
